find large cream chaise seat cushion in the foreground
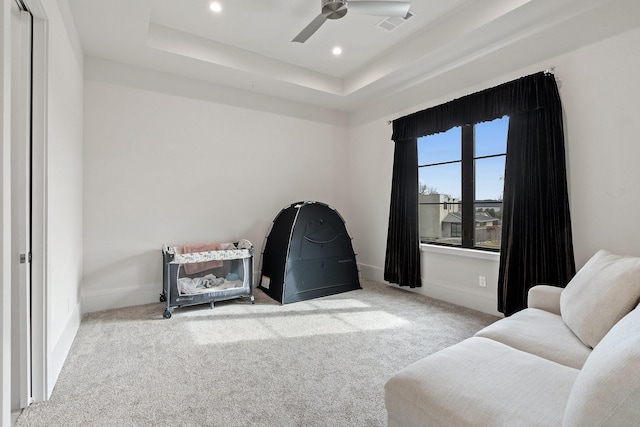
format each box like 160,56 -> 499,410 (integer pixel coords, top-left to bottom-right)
385,337 -> 579,427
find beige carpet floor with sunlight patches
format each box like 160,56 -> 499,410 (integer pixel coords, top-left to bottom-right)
17,281 -> 496,427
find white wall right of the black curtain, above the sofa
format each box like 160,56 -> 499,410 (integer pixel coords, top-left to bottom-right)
559,30 -> 640,266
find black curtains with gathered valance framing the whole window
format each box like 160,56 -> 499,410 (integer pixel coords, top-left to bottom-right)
385,72 -> 575,315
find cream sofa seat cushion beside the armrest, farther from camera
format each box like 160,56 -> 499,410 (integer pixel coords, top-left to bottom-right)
476,308 -> 591,369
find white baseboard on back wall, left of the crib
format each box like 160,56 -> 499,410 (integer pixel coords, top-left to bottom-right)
82,284 -> 162,313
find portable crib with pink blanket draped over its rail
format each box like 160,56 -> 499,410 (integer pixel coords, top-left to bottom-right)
160,240 -> 255,319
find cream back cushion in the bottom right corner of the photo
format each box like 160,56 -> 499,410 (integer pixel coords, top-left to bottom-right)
563,308 -> 640,427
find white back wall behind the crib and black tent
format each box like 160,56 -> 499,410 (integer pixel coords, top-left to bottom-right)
83,60 -> 349,315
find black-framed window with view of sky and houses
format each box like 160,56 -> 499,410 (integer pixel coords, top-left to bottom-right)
418,116 -> 509,250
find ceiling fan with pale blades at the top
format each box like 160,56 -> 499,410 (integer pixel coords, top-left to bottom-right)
292,0 -> 411,43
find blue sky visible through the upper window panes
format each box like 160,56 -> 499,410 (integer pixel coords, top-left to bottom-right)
418,116 -> 509,200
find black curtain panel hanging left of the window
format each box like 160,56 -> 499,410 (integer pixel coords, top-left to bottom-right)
384,138 -> 422,288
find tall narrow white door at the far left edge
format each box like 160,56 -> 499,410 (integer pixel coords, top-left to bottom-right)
11,0 -> 32,411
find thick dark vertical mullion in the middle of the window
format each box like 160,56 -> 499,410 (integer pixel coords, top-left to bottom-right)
462,125 -> 475,248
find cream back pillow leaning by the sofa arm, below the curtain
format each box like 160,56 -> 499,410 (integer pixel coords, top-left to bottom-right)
560,250 -> 640,348
